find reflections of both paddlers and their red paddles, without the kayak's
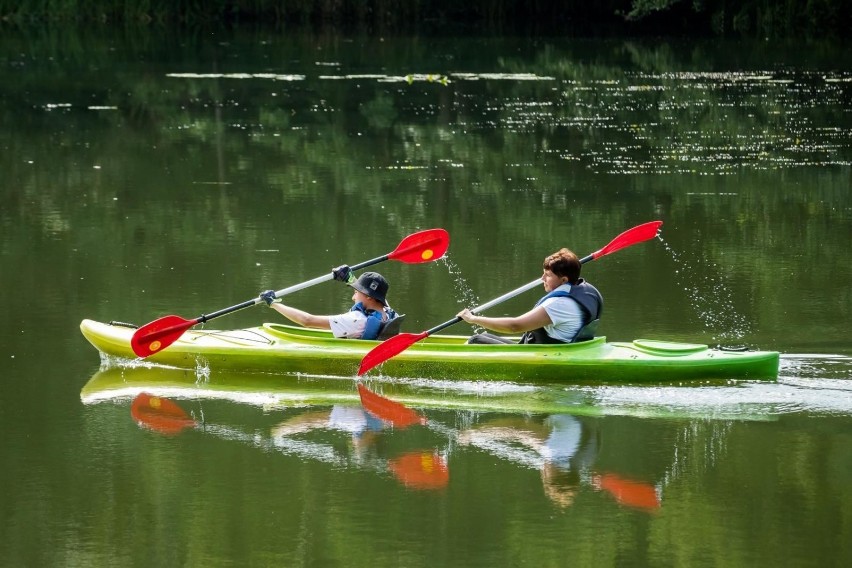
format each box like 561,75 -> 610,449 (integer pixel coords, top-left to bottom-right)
103,374 -> 661,510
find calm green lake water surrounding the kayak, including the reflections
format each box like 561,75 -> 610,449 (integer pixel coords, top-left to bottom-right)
0,30 -> 852,566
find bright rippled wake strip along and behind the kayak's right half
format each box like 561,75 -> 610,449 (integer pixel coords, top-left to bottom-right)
350,370 -> 852,421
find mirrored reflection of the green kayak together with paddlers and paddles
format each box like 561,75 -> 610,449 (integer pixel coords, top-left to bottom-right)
81,367 -> 660,509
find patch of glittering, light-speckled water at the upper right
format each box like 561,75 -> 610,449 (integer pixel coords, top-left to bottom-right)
520,71 -> 852,176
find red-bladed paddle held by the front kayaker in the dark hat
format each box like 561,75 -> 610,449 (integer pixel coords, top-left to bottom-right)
130,229 -> 450,357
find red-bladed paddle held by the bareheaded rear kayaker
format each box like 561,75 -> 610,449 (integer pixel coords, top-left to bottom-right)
358,221 -> 663,376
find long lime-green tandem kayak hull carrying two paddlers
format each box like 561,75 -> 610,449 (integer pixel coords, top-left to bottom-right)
80,320 -> 779,383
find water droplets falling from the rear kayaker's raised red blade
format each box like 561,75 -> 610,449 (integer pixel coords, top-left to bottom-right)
657,235 -> 753,344
